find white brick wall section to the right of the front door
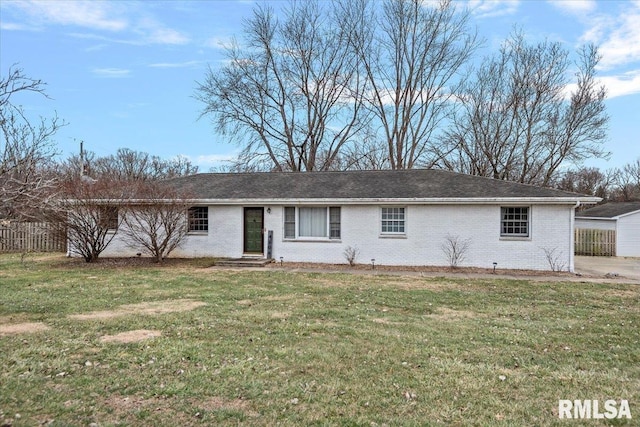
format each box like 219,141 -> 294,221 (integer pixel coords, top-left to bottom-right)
267,205 -> 572,270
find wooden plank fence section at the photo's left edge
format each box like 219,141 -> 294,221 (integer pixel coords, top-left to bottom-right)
0,222 -> 67,252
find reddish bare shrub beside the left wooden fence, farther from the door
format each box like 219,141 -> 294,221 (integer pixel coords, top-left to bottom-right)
46,177 -> 130,262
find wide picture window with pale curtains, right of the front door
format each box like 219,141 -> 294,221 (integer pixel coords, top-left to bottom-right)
284,206 -> 340,239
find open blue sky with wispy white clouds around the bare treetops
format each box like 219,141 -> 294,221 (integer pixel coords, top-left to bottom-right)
0,0 -> 640,171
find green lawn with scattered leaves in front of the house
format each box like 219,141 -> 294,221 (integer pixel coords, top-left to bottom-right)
0,255 -> 640,426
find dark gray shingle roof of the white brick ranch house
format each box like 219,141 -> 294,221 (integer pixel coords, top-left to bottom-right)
168,169 -> 598,202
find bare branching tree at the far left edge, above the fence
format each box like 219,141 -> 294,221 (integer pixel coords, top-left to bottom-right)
0,67 -> 64,218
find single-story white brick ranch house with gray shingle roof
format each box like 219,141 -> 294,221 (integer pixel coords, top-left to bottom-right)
103,170 -> 600,271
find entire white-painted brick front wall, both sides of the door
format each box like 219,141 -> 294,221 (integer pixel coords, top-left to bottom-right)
104,205 -> 573,270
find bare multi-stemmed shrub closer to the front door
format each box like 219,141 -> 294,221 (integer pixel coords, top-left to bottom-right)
120,182 -> 190,263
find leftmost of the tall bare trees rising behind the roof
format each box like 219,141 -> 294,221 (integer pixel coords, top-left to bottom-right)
195,0 -> 367,171
